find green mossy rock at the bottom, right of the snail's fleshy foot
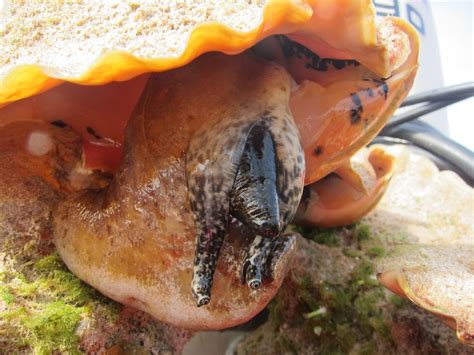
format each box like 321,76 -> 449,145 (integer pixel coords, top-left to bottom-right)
237,223 -> 463,354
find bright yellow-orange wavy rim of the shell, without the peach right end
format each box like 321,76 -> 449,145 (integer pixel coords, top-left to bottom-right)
0,1 -> 312,107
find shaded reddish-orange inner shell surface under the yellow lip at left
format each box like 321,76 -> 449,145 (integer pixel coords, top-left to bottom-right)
0,74 -> 149,172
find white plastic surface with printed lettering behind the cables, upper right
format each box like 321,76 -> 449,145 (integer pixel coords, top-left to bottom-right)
374,0 -> 474,150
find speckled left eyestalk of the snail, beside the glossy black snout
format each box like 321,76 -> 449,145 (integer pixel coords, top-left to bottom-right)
186,115 -> 268,306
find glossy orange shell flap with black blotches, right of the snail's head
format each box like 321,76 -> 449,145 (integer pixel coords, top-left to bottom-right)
290,19 -> 419,184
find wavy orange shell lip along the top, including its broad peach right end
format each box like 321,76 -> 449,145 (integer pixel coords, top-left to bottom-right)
0,0 -> 411,107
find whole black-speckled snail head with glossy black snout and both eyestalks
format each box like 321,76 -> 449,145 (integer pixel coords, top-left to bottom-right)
186,54 -> 304,306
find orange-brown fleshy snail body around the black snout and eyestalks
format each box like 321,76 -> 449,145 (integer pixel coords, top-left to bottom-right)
54,54 -> 304,329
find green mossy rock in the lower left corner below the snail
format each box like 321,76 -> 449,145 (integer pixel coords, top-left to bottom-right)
0,228 -> 190,354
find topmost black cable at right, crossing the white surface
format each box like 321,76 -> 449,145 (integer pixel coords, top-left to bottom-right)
400,81 -> 474,107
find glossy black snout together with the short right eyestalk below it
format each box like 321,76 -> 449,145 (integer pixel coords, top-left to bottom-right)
231,121 -> 292,290
